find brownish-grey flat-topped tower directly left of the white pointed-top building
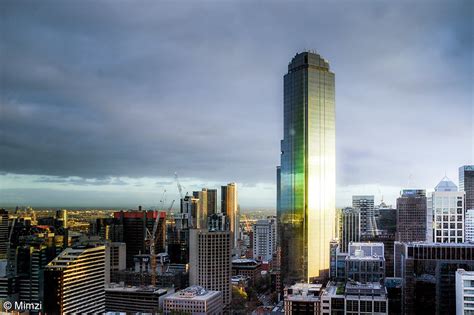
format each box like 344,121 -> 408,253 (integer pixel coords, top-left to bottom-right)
397,189 -> 431,242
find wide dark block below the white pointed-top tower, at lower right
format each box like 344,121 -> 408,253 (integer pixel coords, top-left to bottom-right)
394,242 -> 474,315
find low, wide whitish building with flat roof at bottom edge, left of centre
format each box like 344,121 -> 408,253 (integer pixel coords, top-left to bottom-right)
163,286 -> 224,314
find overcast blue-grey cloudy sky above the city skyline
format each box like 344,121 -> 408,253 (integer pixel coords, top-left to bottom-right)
0,0 -> 474,209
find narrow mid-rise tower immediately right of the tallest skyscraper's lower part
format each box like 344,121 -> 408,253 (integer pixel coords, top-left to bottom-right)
339,208 -> 361,253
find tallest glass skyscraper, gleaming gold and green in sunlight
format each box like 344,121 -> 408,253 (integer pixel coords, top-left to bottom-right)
277,52 -> 336,283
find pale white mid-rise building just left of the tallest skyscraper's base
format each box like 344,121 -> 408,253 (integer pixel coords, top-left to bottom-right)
252,218 -> 277,261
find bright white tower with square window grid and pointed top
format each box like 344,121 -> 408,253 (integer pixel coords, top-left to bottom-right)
428,177 -> 465,243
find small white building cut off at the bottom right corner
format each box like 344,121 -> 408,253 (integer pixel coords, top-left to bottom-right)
456,269 -> 474,315
